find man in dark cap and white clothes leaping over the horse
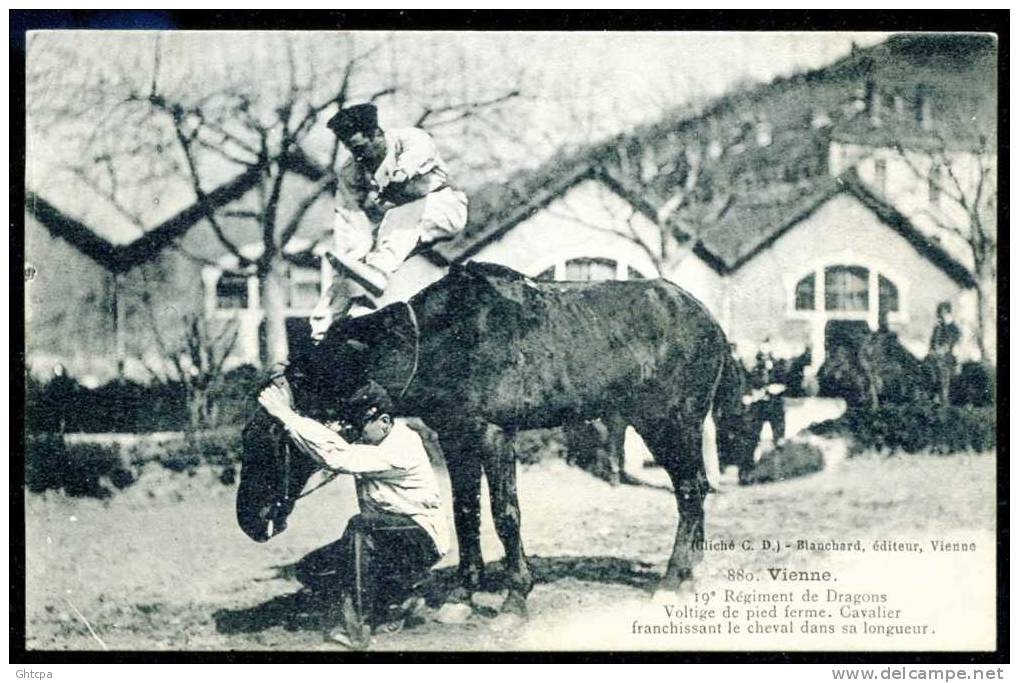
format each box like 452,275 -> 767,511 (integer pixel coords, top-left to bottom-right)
310,104 -> 467,340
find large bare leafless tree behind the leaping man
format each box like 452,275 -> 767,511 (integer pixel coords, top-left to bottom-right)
30,34 -> 519,364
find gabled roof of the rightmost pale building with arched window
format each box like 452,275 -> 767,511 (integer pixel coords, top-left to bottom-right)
694,171 -> 975,287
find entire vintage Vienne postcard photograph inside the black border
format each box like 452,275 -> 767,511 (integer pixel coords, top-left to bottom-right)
11,13 -> 1008,661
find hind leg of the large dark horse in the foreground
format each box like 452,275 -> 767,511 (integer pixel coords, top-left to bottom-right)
639,416 -> 707,590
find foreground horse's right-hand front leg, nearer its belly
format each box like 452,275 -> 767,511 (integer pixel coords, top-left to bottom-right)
481,424 -> 534,616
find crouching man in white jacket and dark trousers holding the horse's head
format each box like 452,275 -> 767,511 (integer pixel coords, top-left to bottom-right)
259,382 -> 449,648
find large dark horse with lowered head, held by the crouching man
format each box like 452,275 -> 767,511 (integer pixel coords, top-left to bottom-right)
237,263 -> 740,613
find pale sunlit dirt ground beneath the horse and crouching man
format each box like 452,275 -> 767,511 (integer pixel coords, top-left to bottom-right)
25,442 -> 995,650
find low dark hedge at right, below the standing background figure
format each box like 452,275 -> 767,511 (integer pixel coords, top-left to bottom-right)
810,403 -> 998,454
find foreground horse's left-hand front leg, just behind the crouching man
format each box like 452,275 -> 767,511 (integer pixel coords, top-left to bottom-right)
440,432 -> 484,602
